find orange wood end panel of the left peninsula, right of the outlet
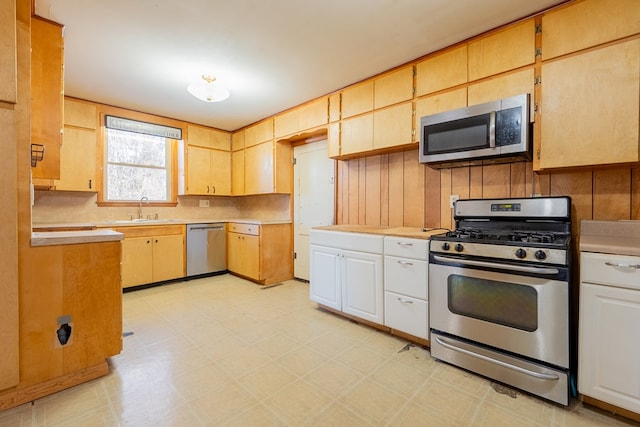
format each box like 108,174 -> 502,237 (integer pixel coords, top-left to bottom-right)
60,242 -> 122,374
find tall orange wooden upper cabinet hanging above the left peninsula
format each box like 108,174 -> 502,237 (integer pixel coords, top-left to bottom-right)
31,17 -> 64,179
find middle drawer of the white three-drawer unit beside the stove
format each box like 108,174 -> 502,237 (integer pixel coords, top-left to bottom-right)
384,255 -> 429,299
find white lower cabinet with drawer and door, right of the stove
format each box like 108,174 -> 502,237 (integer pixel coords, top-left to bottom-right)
578,252 -> 640,413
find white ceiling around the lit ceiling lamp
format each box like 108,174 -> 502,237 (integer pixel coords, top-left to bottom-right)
36,0 -> 564,130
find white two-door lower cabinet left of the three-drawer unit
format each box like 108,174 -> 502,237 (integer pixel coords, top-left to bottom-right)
309,230 -> 384,325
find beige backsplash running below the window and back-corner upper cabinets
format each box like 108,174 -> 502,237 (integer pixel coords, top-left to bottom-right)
32,191 -> 291,223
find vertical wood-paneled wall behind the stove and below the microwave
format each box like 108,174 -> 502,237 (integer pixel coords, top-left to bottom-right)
336,149 -> 640,241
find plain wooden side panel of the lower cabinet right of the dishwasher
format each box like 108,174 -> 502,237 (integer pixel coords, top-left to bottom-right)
260,224 -> 293,281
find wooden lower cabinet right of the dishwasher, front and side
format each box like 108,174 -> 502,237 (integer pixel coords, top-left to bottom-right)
227,222 -> 293,285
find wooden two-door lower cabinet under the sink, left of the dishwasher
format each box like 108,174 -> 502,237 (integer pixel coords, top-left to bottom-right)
116,225 -> 185,288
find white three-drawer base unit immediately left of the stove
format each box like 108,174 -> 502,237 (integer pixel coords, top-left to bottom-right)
384,236 -> 429,339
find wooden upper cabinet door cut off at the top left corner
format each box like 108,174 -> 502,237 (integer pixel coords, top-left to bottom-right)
0,0 -> 18,104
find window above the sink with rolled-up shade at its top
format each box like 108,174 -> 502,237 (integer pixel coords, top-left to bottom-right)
103,116 -> 181,203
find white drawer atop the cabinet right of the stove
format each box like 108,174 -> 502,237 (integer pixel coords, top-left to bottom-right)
580,252 -> 640,289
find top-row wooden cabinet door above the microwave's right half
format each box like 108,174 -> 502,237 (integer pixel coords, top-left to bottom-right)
469,19 -> 536,81
